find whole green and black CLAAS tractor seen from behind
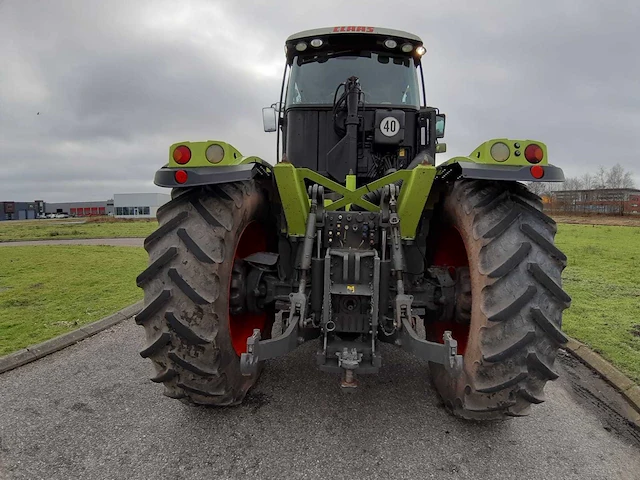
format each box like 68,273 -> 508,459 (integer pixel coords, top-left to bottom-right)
136,26 -> 571,419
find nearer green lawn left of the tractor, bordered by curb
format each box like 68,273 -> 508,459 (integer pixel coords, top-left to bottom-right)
0,245 -> 147,355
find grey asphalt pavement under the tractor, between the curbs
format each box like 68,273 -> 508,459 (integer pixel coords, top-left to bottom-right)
0,320 -> 640,480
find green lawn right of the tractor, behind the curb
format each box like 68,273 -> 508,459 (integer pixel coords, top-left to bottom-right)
556,224 -> 640,383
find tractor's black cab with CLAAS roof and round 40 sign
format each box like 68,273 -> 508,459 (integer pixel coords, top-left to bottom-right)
263,26 -> 444,184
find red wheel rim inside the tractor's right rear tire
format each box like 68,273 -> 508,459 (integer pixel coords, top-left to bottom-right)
427,226 -> 469,355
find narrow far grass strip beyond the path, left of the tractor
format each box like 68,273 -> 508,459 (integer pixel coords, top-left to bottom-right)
0,219 -> 158,242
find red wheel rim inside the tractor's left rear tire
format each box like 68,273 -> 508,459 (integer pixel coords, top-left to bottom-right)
227,222 -> 267,356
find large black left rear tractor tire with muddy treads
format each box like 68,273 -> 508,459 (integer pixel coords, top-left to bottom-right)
136,182 -> 272,406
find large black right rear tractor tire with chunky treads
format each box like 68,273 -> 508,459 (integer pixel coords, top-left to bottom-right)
427,180 -> 571,420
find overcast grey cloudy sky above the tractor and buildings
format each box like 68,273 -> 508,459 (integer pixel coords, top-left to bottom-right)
0,0 -> 640,202
